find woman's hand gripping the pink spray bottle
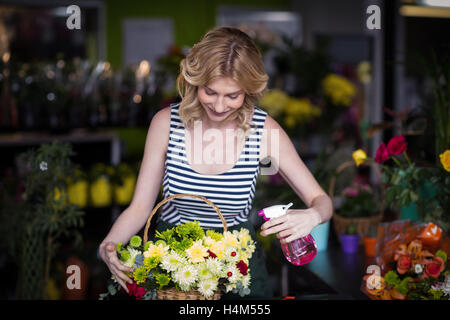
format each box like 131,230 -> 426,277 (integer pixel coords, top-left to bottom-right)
261,207 -> 321,243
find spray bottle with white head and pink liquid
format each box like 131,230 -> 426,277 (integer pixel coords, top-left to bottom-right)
258,202 -> 317,266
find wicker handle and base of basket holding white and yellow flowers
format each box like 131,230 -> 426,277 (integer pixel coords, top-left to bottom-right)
144,193 -> 228,300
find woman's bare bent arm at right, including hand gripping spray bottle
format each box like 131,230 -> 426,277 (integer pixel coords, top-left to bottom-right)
261,116 -> 333,242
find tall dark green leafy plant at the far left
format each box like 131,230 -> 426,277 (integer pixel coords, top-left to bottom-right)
16,142 -> 84,298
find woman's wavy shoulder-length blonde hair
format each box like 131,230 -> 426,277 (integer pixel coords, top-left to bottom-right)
177,27 -> 269,136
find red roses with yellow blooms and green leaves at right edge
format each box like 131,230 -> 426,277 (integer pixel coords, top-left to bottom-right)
352,136 -> 450,225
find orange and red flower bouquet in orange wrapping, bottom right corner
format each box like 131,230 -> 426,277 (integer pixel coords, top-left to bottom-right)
362,221 -> 450,300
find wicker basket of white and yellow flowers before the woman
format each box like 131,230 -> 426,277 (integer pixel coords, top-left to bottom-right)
100,194 -> 255,300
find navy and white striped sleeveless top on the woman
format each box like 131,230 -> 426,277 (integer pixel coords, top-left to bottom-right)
159,103 -> 267,228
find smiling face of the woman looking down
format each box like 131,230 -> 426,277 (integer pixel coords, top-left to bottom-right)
197,77 -> 245,122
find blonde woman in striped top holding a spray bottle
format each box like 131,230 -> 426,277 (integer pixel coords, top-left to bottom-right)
99,27 -> 332,297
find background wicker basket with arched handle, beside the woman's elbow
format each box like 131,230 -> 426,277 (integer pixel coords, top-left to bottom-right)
328,160 -> 385,243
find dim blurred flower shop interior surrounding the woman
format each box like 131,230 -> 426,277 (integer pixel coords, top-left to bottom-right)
0,0 -> 450,300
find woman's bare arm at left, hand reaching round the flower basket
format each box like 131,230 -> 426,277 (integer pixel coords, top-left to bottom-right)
99,108 -> 170,291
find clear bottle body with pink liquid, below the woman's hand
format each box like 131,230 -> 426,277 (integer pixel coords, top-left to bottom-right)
281,234 -> 317,266
